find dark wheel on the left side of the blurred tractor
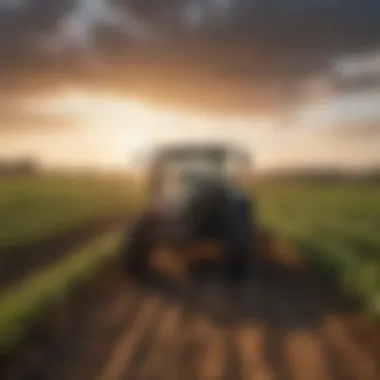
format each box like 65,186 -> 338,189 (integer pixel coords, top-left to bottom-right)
123,214 -> 154,281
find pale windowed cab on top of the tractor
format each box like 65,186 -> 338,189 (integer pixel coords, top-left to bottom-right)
149,144 -> 251,209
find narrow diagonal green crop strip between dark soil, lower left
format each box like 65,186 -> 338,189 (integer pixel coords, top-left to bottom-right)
0,232 -> 121,354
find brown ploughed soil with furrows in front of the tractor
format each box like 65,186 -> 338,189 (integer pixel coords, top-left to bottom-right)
1,233 -> 380,380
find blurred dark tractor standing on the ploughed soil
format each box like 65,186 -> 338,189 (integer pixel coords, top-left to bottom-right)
122,143 -> 256,281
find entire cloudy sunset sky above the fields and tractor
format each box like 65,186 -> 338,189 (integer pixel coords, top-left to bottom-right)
0,0 -> 380,169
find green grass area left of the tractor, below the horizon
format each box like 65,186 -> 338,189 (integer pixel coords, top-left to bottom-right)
0,176 -> 141,252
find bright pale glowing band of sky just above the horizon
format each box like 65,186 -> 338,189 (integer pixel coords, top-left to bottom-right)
0,89 -> 380,168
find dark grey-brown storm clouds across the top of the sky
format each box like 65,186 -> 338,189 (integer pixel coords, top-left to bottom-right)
0,0 -> 380,120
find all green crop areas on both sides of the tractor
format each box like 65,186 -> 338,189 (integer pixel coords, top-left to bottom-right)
0,178 -> 380,347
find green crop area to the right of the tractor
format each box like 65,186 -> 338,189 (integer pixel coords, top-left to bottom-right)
258,183 -> 380,317
